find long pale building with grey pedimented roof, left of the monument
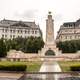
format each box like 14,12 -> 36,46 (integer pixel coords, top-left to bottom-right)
0,19 -> 42,39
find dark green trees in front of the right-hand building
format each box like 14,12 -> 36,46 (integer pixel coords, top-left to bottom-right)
57,40 -> 80,53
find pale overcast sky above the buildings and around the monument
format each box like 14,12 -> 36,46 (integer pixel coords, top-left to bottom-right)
0,0 -> 80,38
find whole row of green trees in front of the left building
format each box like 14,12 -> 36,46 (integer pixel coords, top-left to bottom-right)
0,36 -> 44,53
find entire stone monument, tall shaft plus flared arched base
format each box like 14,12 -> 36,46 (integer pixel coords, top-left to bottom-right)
40,12 -> 59,56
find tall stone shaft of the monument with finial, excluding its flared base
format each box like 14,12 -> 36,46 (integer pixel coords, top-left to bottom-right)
46,12 -> 54,44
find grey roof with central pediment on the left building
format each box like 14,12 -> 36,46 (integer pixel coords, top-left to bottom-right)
0,19 -> 39,28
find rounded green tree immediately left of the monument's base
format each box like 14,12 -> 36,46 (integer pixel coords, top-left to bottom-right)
22,37 -> 44,53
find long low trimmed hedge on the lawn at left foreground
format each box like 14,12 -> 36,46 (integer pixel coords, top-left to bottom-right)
0,64 -> 27,71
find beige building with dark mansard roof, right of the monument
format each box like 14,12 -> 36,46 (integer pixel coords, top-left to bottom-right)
56,19 -> 80,41
